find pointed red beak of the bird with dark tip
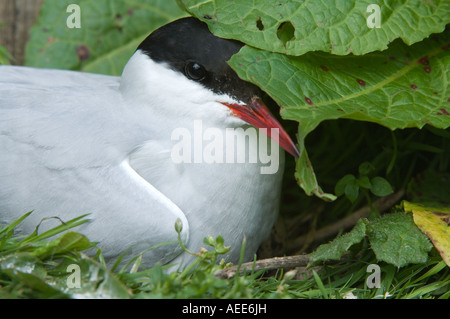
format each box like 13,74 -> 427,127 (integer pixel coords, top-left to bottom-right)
222,97 -> 300,158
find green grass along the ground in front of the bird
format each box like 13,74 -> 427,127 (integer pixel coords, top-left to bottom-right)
0,210 -> 450,299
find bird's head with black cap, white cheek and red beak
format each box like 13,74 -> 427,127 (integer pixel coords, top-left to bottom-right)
121,17 -> 299,157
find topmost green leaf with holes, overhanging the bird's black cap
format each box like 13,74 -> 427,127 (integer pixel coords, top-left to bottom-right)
178,0 -> 450,55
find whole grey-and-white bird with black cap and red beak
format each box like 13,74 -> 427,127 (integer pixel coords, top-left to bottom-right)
0,17 -> 299,269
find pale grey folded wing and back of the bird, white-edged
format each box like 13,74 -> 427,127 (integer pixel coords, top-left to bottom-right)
0,67 -> 189,265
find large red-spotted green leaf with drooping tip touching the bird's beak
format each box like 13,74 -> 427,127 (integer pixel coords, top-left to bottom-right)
229,33 -> 450,199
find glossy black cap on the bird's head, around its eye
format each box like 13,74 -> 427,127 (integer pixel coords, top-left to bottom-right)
138,17 -> 261,103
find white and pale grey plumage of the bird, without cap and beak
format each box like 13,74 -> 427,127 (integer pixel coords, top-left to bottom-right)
0,51 -> 284,265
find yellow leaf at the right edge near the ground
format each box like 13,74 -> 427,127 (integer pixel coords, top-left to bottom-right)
403,201 -> 450,267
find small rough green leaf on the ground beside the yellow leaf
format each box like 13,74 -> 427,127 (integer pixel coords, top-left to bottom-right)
367,212 -> 433,267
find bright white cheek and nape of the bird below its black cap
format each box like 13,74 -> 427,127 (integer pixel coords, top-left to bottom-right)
120,50 -> 246,140
